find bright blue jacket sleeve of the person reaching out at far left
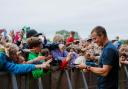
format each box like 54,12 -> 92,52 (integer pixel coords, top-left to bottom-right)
0,52 -> 35,74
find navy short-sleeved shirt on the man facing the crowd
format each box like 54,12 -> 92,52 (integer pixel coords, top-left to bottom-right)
98,42 -> 119,89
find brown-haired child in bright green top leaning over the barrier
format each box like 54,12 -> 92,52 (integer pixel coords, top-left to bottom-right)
27,37 -> 51,78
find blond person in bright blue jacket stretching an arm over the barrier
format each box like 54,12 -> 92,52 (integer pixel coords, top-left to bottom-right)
0,43 -> 50,74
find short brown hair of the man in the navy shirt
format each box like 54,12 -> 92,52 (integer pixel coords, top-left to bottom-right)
91,26 -> 107,37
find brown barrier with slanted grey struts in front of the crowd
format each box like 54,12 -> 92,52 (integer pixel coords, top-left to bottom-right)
0,66 -> 128,89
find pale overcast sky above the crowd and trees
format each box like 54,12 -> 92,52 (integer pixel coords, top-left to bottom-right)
0,0 -> 128,39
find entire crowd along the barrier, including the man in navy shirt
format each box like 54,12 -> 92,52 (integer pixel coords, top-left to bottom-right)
0,26 -> 128,89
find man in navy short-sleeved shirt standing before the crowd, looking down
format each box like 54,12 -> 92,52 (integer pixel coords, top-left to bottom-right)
79,26 -> 119,89
